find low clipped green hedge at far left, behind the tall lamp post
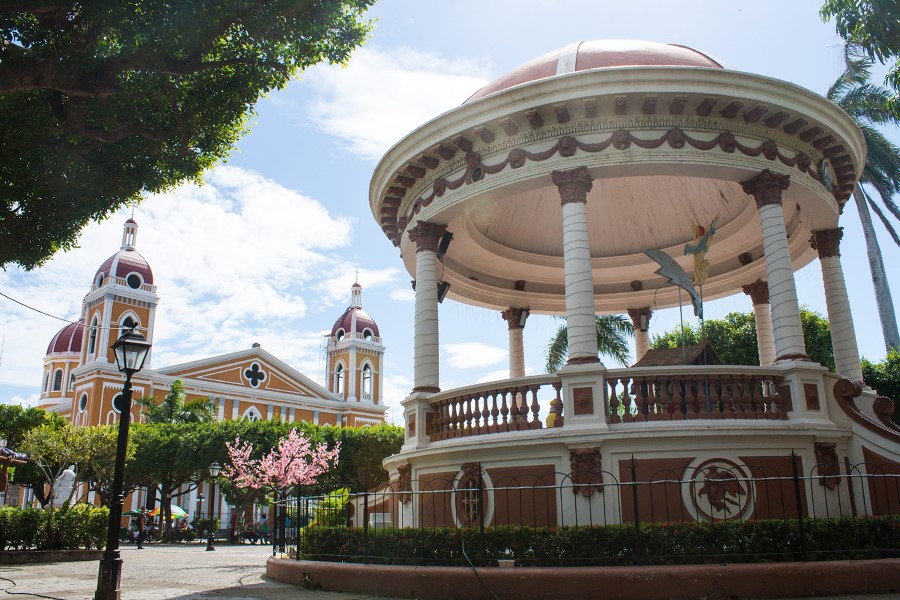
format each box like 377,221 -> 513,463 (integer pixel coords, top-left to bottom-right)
0,504 -> 109,550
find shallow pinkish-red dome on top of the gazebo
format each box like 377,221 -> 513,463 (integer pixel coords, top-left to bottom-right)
466,40 -> 724,102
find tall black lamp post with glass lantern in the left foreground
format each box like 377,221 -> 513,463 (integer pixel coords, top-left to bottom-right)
94,328 -> 150,600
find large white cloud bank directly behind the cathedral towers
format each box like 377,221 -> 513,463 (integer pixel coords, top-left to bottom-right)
0,166 -> 358,386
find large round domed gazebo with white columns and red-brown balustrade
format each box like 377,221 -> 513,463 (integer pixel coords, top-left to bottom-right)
370,41 -> 900,524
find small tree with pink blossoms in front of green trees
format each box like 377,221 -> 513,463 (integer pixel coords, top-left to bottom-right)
222,429 -> 341,540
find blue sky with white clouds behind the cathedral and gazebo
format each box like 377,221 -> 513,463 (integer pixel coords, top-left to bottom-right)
0,0 -> 900,422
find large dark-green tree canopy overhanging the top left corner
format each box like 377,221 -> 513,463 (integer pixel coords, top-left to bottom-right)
0,0 -> 374,268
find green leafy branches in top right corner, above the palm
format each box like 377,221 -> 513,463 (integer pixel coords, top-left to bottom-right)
819,0 -> 900,90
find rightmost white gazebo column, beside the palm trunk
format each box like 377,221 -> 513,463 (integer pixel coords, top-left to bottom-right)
811,227 -> 863,381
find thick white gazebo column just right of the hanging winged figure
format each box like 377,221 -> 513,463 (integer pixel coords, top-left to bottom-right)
741,169 -> 809,362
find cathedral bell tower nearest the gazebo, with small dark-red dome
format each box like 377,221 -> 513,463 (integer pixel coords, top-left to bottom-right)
326,283 -> 384,404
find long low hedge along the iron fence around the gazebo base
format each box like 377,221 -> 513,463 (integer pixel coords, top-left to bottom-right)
298,516 -> 900,567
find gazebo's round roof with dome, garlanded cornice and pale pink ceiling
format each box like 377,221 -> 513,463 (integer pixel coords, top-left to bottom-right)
370,42 -> 865,313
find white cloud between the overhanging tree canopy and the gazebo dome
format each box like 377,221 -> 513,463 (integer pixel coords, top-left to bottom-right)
303,47 -> 490,161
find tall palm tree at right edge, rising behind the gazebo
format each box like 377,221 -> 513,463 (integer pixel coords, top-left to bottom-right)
826,45 -> 900,351
